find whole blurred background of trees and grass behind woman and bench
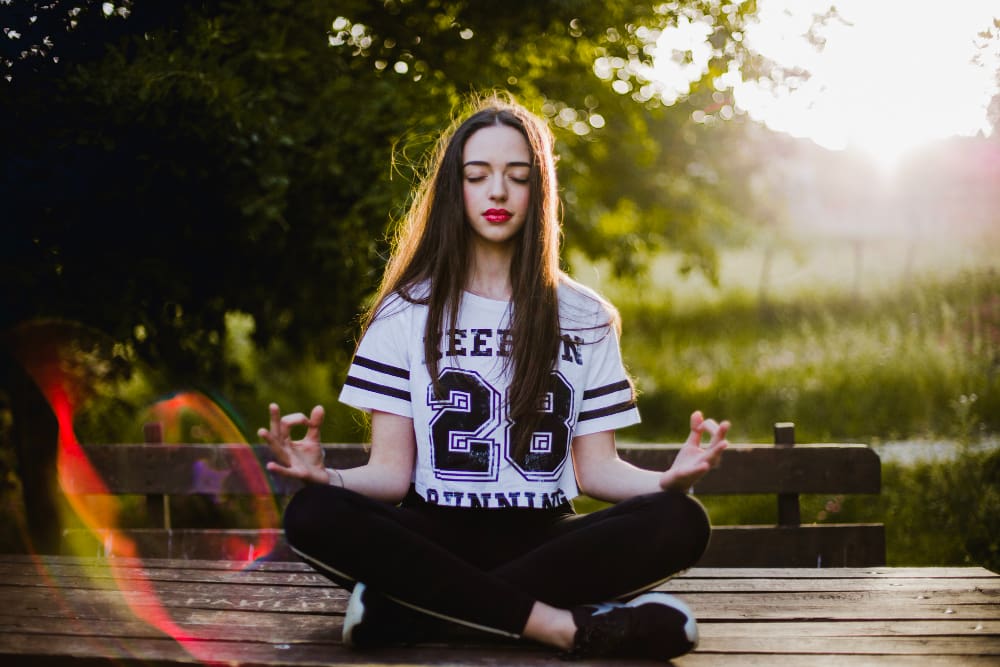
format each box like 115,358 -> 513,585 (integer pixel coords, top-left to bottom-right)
0,0 -> 1000,568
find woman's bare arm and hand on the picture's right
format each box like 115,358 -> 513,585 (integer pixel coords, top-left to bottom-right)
573,412 -> 729,502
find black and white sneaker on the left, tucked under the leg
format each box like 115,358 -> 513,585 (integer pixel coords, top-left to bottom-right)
343,581 -> 424,649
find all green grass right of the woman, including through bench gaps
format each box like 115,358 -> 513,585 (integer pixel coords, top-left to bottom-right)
577,232 -> 1000,571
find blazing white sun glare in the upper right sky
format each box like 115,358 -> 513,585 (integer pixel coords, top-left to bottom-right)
735,0 -> 1000,169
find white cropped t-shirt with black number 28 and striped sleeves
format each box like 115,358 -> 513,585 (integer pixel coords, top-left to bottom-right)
340,280 -> 639,508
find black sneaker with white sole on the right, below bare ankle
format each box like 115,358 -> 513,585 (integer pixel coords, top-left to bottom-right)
566,593 -> 698,660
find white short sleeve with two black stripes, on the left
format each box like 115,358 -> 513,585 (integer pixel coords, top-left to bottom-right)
340,297 -> 413,417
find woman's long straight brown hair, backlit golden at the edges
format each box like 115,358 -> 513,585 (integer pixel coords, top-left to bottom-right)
362,95 -> 562,457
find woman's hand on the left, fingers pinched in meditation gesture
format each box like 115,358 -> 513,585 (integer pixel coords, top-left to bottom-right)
257,403 -> 330,484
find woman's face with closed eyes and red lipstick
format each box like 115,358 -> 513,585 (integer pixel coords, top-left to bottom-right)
462,125 -> 531,245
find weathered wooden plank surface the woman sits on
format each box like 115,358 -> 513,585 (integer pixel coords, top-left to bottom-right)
0,555 -> 1000,667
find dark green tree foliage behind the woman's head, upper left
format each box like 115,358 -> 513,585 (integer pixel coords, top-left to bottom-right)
0,0 -> 753,380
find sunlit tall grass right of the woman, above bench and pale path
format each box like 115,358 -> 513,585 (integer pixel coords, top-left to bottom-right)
577,232 -> 1000,443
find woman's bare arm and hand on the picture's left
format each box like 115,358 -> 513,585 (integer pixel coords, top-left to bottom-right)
257,403 -> 416,503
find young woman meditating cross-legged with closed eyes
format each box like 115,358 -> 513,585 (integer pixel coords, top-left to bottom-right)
260,97 -> 729,659
